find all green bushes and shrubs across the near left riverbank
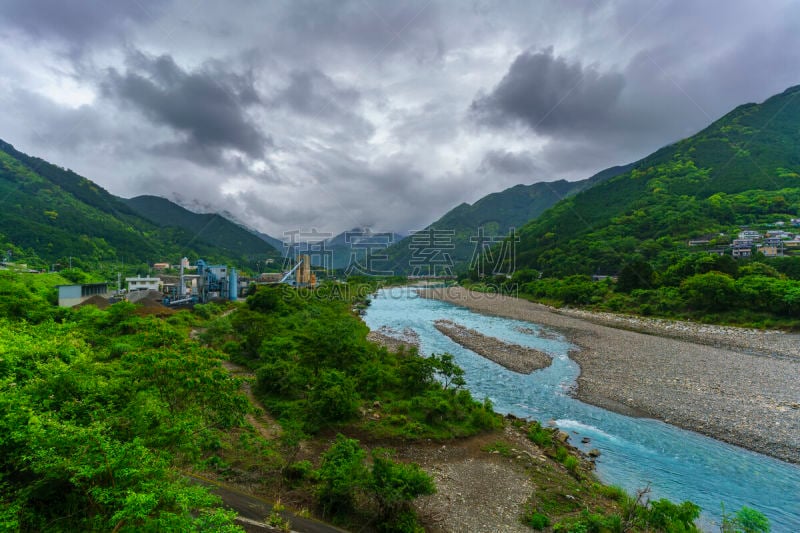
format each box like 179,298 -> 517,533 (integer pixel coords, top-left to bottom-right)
0,272 -> 768,532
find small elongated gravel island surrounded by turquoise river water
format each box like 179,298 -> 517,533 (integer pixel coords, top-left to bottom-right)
434,319 -> 553,374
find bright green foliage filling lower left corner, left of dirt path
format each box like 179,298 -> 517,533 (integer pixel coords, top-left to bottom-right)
0,275 -> 247,531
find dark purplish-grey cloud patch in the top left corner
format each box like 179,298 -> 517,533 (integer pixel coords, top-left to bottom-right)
0,0 -> 167,47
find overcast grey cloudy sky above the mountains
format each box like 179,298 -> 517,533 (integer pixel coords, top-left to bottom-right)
0,0 -> 800,236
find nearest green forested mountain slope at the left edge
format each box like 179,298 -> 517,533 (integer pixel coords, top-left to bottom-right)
0,141 -> 275,266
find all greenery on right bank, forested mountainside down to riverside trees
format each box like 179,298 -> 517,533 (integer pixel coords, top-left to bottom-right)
467,87 -> 800,327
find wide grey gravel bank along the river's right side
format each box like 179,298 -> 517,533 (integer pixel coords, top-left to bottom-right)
420,287 -> 800,463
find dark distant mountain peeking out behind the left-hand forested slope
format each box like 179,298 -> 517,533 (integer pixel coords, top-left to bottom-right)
122,195 -> 282,258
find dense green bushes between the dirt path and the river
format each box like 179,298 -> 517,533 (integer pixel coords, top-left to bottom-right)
219,284 -> 500,439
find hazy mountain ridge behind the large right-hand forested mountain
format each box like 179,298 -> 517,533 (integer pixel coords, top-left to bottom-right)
382,164 -> 634,274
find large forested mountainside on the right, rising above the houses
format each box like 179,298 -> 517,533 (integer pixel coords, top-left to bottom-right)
516,86 -> 800,276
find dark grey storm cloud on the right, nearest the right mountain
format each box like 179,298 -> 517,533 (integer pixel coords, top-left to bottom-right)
471,48 -> 625,133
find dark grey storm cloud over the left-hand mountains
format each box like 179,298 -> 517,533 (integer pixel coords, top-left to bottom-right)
103,53 -> 271,162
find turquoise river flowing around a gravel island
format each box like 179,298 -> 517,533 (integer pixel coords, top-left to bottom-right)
364,288 -> 800,533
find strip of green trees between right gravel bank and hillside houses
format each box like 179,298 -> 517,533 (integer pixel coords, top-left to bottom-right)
464,253 -> 800,330
